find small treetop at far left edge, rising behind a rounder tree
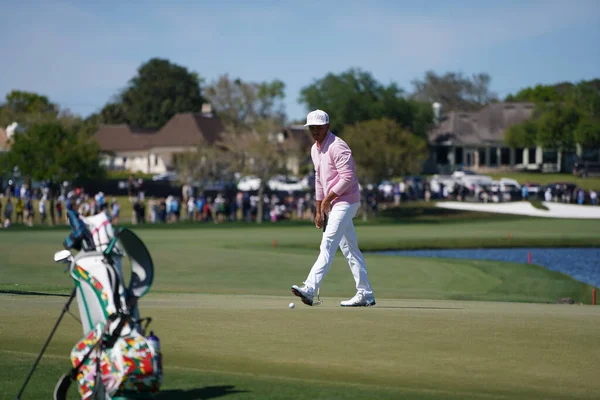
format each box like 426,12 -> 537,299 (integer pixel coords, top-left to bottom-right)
0,90 -> 60,126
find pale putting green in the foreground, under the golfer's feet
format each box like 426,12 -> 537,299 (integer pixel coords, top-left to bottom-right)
0,294 -> 600,399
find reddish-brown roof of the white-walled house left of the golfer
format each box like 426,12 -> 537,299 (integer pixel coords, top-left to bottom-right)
94,113 -> 225,152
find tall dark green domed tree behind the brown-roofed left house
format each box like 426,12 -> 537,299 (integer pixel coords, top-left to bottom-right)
101,58 -> 204,128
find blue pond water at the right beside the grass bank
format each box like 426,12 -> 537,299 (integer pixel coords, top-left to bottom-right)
376,247 -> 600,287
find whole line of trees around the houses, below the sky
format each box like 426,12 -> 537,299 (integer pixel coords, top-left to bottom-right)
0,58 -> 600,219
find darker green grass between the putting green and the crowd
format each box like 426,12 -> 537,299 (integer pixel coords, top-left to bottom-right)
0,219 -> 600,302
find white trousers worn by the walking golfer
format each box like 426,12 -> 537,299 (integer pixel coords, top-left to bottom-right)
304,203 -> 373,297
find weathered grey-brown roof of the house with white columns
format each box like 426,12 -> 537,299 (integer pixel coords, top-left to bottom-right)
428,103 -> 535,145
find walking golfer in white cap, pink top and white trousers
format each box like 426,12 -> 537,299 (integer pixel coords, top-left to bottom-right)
292,110 -> 375,307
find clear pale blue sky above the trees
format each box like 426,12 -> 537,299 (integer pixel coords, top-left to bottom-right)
0,0 -> 600,119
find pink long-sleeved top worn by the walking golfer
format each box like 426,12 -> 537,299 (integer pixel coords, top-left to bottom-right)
310,132 -> 360,205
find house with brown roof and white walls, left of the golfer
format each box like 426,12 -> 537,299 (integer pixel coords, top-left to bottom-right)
95,113 -> 225,174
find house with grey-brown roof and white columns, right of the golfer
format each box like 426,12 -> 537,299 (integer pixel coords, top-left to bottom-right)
426,103 -> 563,172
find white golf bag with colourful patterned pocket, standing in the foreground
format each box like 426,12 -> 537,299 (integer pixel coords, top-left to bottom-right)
54,210 -> 162,400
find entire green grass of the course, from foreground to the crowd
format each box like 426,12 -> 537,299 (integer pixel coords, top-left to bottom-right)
0,220 -> 600,400
